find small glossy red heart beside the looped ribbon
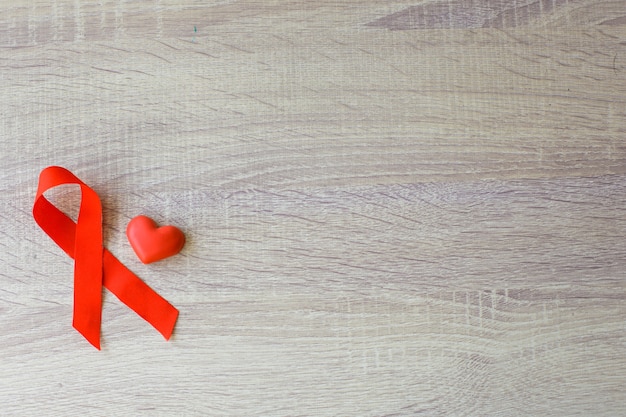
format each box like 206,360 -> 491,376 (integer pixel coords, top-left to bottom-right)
126,216 -> 185,264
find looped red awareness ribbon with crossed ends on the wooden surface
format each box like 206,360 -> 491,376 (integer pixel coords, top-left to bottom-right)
33,166 -> 178,350
